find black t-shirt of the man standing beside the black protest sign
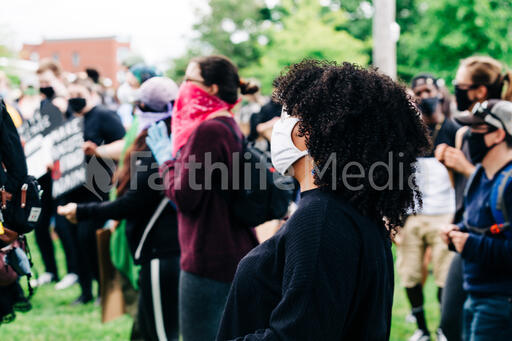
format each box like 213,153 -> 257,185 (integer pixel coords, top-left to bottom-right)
84,105 -> 126,146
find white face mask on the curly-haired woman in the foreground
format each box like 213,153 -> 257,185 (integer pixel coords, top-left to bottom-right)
270,109 -> 308,175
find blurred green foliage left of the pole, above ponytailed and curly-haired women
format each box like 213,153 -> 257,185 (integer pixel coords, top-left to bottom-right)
172,0 -> 369,93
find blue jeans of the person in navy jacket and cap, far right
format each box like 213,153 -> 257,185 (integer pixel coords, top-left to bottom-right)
464,294 -> 512,341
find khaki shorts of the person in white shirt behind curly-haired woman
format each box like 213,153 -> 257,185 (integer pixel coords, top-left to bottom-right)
397,214 -> 453,288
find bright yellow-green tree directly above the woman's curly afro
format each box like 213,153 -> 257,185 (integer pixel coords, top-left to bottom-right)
242,0 -> 369,93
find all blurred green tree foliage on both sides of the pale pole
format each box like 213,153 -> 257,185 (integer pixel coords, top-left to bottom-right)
171,0 -> 512,92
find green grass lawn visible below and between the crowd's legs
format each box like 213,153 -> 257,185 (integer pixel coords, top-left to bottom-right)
0,234 -> 439,341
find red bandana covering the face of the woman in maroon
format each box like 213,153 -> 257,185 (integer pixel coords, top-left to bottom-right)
171,82 -> 235,157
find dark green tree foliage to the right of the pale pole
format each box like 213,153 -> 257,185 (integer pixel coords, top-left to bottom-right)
398,0 -> 512,81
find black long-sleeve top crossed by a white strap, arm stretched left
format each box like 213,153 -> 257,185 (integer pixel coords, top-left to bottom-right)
76,150 -> 180,263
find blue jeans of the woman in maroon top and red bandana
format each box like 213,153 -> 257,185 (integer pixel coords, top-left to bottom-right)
178,270 -> 231,341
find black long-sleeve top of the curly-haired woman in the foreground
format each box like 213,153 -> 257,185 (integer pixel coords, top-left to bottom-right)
217,189 -> 393,341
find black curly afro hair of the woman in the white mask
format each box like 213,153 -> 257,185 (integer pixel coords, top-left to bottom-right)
273,59 -> 431,230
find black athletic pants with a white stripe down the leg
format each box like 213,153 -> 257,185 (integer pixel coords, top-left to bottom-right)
137,256 -> 180,341
